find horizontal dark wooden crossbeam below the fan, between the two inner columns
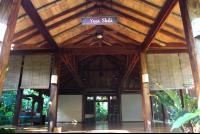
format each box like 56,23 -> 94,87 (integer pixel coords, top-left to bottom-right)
61,46 -> 139,55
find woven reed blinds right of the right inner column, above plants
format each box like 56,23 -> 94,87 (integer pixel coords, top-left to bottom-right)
147,54 -> 194,90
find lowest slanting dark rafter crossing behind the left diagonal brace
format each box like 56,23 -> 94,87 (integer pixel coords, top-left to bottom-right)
13,5 -> 96,46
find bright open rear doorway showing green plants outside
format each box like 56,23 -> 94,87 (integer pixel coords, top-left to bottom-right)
95,102 -> 108,122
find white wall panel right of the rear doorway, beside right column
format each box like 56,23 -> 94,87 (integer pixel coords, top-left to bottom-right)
121,94 -> 143,121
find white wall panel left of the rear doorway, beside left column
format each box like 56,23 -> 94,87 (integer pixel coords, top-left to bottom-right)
57,95 -> 82,122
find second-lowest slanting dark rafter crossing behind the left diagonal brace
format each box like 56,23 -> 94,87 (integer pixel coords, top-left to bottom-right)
13,2 -> 91,39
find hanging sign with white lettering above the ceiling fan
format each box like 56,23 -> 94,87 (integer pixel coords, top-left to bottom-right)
82,14 -> 117,25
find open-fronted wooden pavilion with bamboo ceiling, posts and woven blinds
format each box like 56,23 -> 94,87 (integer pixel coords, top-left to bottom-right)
0,0 -> 200,131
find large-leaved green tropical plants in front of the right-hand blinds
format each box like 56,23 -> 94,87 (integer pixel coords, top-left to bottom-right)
148,83 -> 200,133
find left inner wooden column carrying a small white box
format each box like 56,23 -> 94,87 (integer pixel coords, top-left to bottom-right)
48,54 -> 61,132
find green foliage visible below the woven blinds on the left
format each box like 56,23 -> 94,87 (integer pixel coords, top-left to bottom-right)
0,89 -> 50,126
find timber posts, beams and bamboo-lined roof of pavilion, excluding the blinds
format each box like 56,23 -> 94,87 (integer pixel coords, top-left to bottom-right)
0,0 -> 200,131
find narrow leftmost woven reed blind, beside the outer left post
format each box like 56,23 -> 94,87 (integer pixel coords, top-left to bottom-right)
3,55 -> 22,91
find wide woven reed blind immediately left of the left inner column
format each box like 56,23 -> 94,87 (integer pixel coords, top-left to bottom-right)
20,55 -> 52,89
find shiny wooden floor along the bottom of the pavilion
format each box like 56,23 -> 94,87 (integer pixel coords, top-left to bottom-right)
0,122 -> 179,133
